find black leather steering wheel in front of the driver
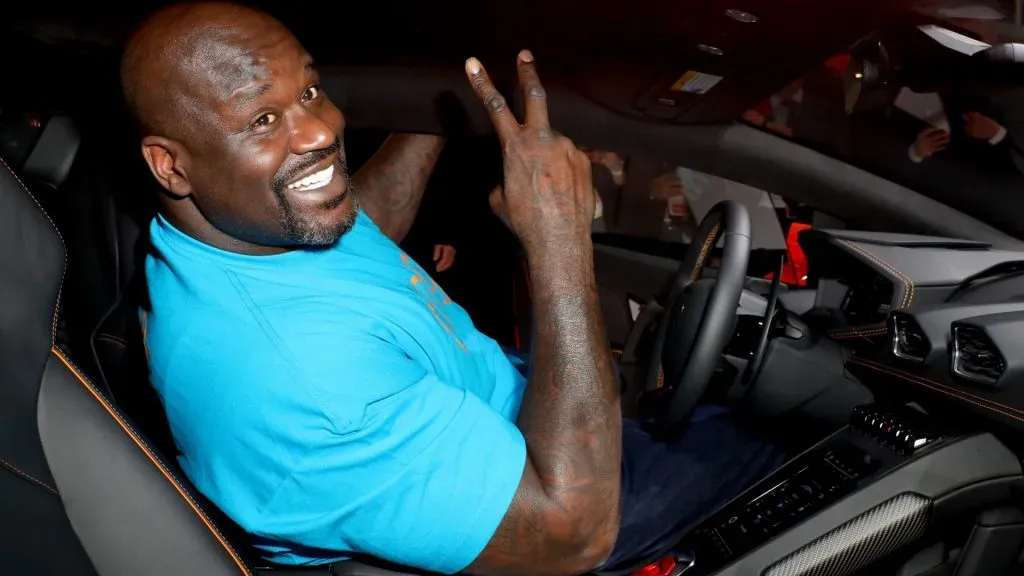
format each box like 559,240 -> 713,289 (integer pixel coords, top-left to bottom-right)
646,200 -> 751,436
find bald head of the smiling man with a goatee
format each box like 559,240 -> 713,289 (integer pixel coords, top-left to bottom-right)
126,4 -> 357,253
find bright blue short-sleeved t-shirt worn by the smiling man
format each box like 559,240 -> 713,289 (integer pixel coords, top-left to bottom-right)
140,212 -> 526,573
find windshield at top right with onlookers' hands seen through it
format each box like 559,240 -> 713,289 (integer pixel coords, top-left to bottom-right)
741,0 -> 1024,237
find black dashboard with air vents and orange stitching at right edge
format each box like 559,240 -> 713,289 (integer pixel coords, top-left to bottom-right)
801,226 -> 1024,433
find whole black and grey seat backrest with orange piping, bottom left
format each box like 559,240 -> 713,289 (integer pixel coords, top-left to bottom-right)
0,153 -> 251,576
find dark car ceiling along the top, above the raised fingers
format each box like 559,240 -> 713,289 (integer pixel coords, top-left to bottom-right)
8,0 -> 914,124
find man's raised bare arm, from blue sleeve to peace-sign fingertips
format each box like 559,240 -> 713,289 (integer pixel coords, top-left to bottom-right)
466,51 -> 622,575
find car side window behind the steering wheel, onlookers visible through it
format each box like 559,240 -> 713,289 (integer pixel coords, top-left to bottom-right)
587,150 -> 797,250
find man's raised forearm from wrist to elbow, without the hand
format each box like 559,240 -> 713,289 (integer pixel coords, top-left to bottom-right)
470,247 -> 622,575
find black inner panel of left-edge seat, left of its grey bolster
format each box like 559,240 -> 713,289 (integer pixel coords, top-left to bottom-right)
0,150 -> 95,576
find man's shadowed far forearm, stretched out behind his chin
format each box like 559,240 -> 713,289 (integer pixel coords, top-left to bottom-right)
352,134 -> 444,242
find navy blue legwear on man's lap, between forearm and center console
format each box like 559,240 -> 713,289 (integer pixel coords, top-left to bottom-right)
601,406 -> 784,572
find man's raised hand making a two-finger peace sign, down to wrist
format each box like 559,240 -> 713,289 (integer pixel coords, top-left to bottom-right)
466,50 -> 594,257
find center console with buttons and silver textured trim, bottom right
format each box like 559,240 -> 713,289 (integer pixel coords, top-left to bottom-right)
677,406 -> 1021,576
